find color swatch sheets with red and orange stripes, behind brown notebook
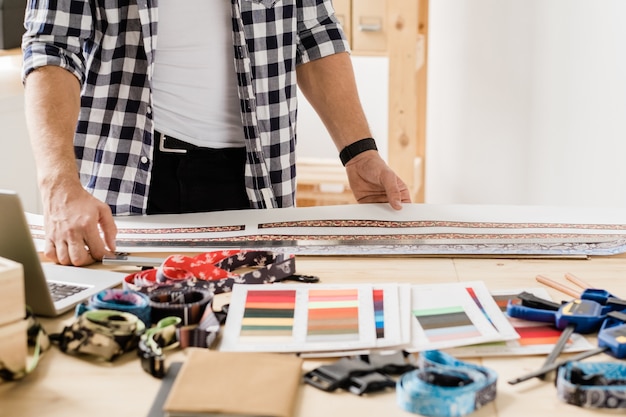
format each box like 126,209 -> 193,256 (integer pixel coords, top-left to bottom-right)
220,284 -> 410,352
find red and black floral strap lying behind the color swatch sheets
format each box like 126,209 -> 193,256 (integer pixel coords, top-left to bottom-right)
124,250 -> 296,294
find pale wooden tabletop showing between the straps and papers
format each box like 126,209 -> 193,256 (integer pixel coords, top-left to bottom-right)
0,255 -> 626,417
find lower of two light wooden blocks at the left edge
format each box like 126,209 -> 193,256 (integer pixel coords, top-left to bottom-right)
0,319 -> 28,383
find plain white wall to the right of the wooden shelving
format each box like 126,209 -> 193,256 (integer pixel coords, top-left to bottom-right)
426,0 -> 626,206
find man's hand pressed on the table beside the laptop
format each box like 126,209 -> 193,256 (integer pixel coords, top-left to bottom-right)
44,188 -> 117,266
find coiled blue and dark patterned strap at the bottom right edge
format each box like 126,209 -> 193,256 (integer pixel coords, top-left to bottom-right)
556,362 -> 626,409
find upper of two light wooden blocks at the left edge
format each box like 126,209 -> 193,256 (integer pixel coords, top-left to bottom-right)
0,258 -> 26,326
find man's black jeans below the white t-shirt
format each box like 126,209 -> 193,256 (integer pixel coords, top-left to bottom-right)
147,134 -> 250,214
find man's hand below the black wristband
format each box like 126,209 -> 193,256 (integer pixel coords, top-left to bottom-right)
346,151 -> 411,210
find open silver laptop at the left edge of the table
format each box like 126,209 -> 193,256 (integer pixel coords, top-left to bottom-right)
0,190 -> 125,317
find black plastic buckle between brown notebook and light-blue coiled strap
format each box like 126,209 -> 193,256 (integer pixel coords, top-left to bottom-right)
304,358 -> 374,392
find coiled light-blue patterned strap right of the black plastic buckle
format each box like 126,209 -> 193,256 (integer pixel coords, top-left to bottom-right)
396,350 -> 497,417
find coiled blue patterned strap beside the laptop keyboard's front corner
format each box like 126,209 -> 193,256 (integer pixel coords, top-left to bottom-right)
75,288 -> 152,327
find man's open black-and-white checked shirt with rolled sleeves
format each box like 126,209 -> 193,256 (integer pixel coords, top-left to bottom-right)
22,0 -> 348,215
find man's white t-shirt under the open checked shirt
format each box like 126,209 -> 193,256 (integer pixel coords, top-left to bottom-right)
152,0 -> 244,148
